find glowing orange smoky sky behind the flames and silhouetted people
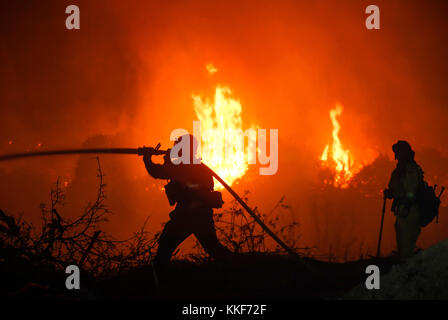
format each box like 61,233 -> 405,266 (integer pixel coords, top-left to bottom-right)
0,0 -> 448,258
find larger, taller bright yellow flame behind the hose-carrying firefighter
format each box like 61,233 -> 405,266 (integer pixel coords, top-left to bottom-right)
192,68 -> 254,189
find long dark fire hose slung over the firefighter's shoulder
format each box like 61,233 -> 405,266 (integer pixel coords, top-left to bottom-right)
0,148 -> 309,269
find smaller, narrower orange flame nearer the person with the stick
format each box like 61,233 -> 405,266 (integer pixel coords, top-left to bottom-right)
320,105 -> 362,188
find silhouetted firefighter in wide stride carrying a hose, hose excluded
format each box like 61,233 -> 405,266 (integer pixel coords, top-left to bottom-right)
143,134 -> 232,271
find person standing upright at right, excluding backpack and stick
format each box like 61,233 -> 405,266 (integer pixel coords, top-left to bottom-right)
384,140 -> 423,260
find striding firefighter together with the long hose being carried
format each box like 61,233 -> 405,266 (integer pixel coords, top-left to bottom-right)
0,134 -> 300,270
